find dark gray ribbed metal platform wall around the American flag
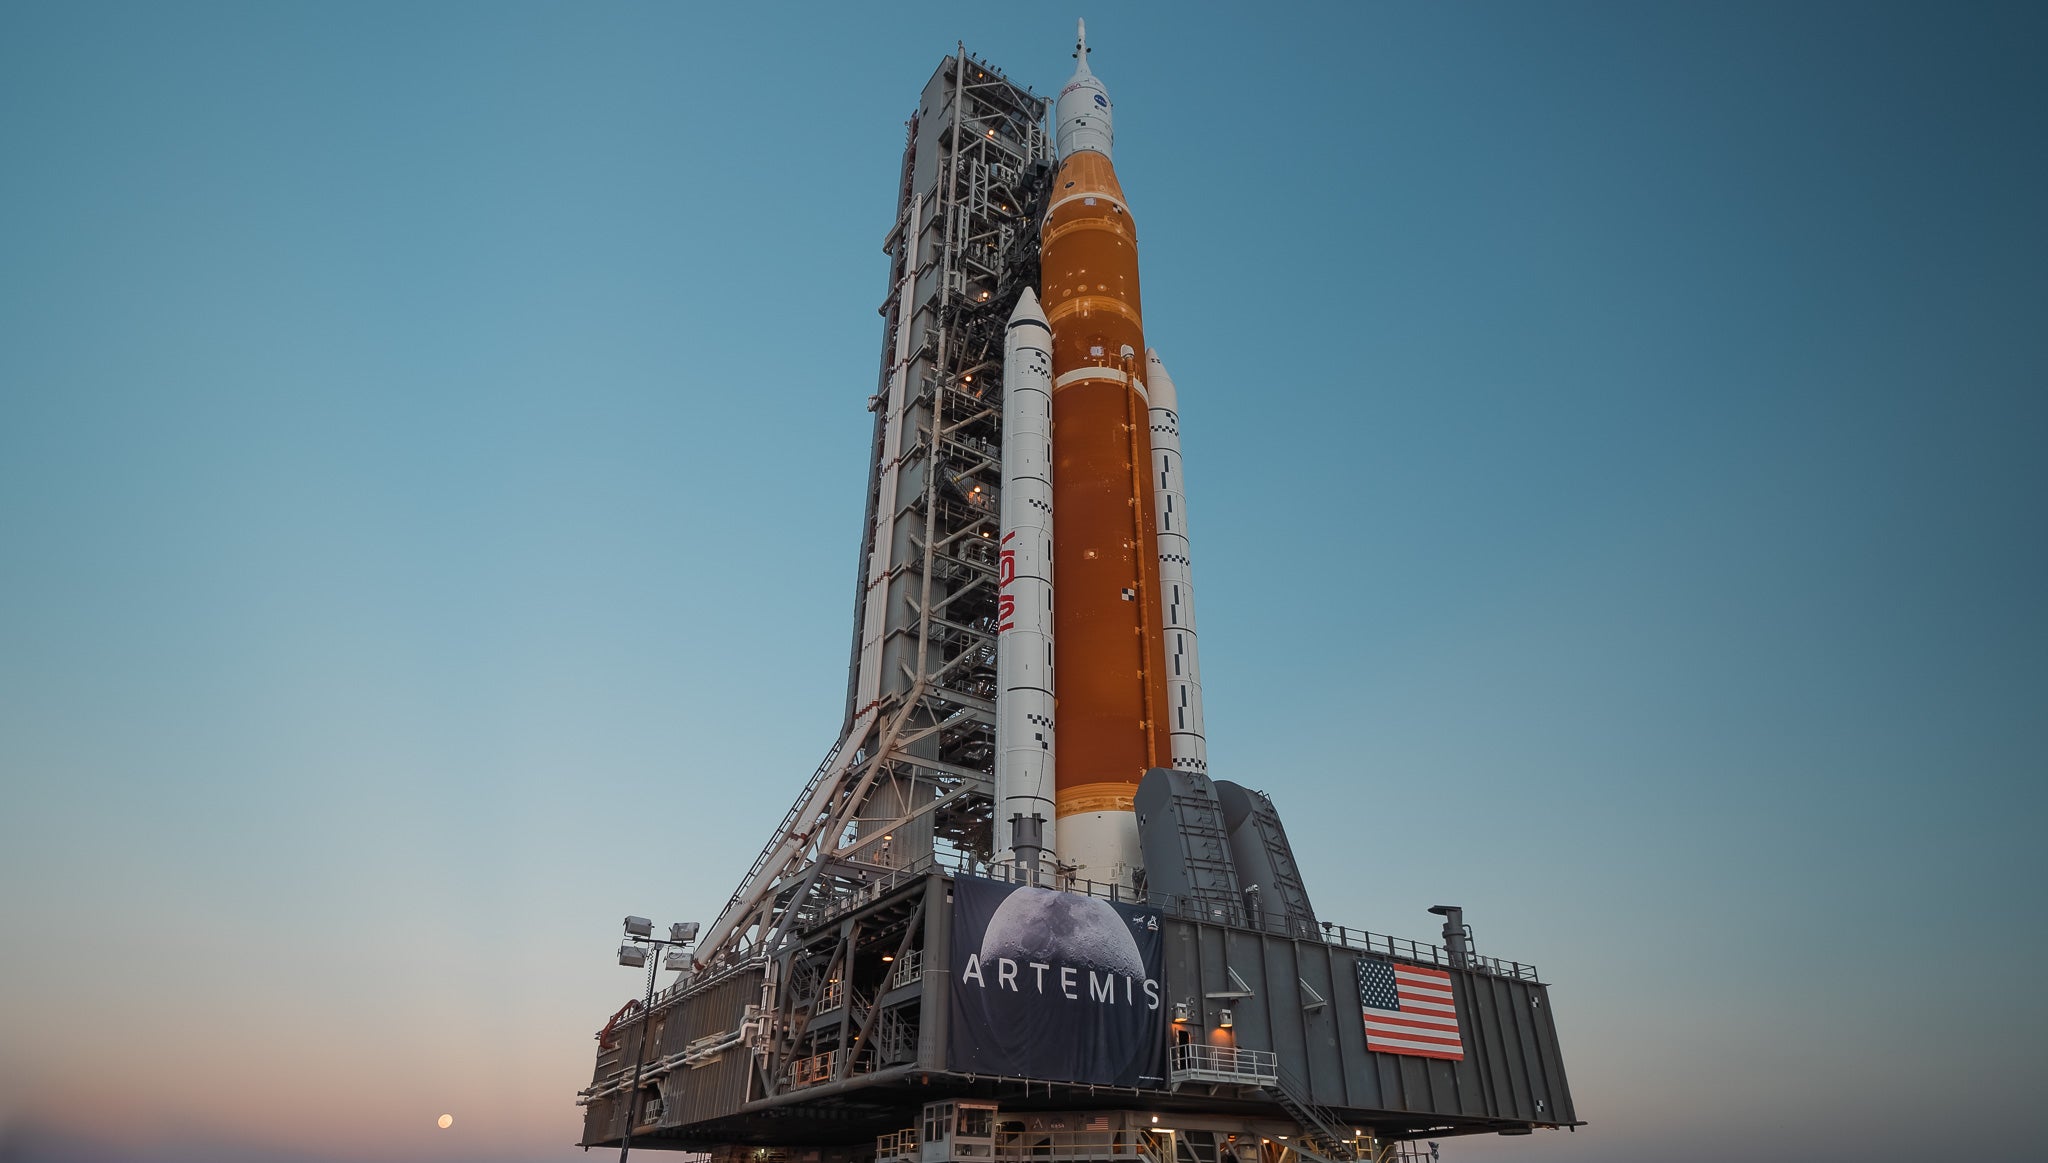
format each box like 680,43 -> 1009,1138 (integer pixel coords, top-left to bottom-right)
1165,919 -> 1577,1124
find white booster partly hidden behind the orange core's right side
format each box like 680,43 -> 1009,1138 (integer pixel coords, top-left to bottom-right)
1145,348 -> 1208,774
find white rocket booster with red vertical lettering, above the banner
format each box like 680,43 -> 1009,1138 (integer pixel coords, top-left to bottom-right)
995,287 -> 1055,870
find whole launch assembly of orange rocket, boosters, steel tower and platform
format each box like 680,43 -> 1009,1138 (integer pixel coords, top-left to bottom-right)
580,27 -> 1577,1163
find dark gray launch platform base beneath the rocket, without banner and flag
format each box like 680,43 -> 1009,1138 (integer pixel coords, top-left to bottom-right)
582,868 -> 1577,1163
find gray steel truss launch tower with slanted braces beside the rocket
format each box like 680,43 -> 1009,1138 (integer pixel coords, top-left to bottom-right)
698,47 -> 1053,970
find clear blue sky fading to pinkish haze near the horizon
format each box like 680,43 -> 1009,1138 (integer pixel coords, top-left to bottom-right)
0,0 -> 2048,1163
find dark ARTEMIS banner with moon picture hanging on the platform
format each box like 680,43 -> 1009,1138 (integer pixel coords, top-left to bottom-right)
946,876 -> 1165,1087
